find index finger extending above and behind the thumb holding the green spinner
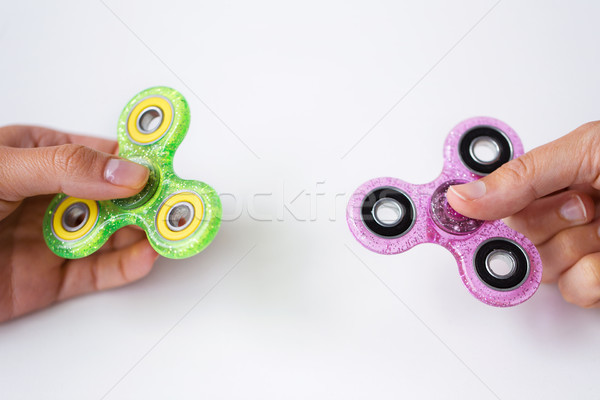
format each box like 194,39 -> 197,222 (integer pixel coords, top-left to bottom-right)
0,125 -> 118,154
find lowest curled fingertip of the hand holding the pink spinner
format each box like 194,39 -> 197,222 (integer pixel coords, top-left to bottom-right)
558,253 -> 600,308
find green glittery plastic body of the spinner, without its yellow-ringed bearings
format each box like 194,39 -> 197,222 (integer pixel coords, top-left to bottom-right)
43,87 -> 221,258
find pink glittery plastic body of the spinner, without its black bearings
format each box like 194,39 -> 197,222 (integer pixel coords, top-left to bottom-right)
347,117 -> 542,307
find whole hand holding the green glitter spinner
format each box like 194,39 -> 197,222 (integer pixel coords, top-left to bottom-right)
0,126 -> 158,322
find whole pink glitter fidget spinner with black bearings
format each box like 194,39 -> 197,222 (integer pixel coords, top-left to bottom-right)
347,117 -> 542,307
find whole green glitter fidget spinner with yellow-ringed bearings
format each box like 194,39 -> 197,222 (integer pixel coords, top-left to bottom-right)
43,87 -> 221,258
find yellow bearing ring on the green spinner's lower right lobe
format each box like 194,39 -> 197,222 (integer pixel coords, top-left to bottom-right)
156,192 -> 204,241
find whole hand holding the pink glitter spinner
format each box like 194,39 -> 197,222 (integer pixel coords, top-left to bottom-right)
448,121 -> 600,308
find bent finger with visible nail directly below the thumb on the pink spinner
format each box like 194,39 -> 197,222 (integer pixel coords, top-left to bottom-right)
504,191 -> 596,246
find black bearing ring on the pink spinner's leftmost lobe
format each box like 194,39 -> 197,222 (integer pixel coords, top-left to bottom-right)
361,187 -> 416,238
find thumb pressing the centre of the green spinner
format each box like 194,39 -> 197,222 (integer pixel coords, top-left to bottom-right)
0,144 -> 149,201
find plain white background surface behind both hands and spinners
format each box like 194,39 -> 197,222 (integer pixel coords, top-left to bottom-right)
0,0 -> 600,399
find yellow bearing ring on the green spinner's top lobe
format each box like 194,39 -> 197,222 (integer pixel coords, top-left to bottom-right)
127,96 -> 173,145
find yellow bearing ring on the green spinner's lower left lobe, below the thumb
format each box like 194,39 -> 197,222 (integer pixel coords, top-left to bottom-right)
52,197 -> 98,240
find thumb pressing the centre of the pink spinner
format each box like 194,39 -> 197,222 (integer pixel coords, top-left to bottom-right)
448,122 -> 600,220
